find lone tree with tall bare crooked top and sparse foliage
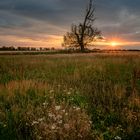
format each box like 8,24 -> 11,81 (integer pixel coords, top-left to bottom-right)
63,0 -> 101,52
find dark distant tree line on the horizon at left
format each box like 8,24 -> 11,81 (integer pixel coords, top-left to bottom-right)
0,46 -> 55,51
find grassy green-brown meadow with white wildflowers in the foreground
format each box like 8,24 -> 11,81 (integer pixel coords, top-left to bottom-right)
0,52 -> 140,140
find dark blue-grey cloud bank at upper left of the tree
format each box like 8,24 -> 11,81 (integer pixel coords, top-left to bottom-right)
0,0 -> 85,26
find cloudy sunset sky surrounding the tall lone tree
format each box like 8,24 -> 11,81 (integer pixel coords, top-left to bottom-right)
0,0 -> 140,49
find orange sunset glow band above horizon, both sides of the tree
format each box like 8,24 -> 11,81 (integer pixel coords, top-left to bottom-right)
0,35 -> 140,49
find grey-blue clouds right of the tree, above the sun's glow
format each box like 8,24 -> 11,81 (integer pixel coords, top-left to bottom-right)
96,0 -> 140,41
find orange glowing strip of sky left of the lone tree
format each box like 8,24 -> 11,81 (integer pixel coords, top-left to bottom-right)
0,35 -> 63,48
